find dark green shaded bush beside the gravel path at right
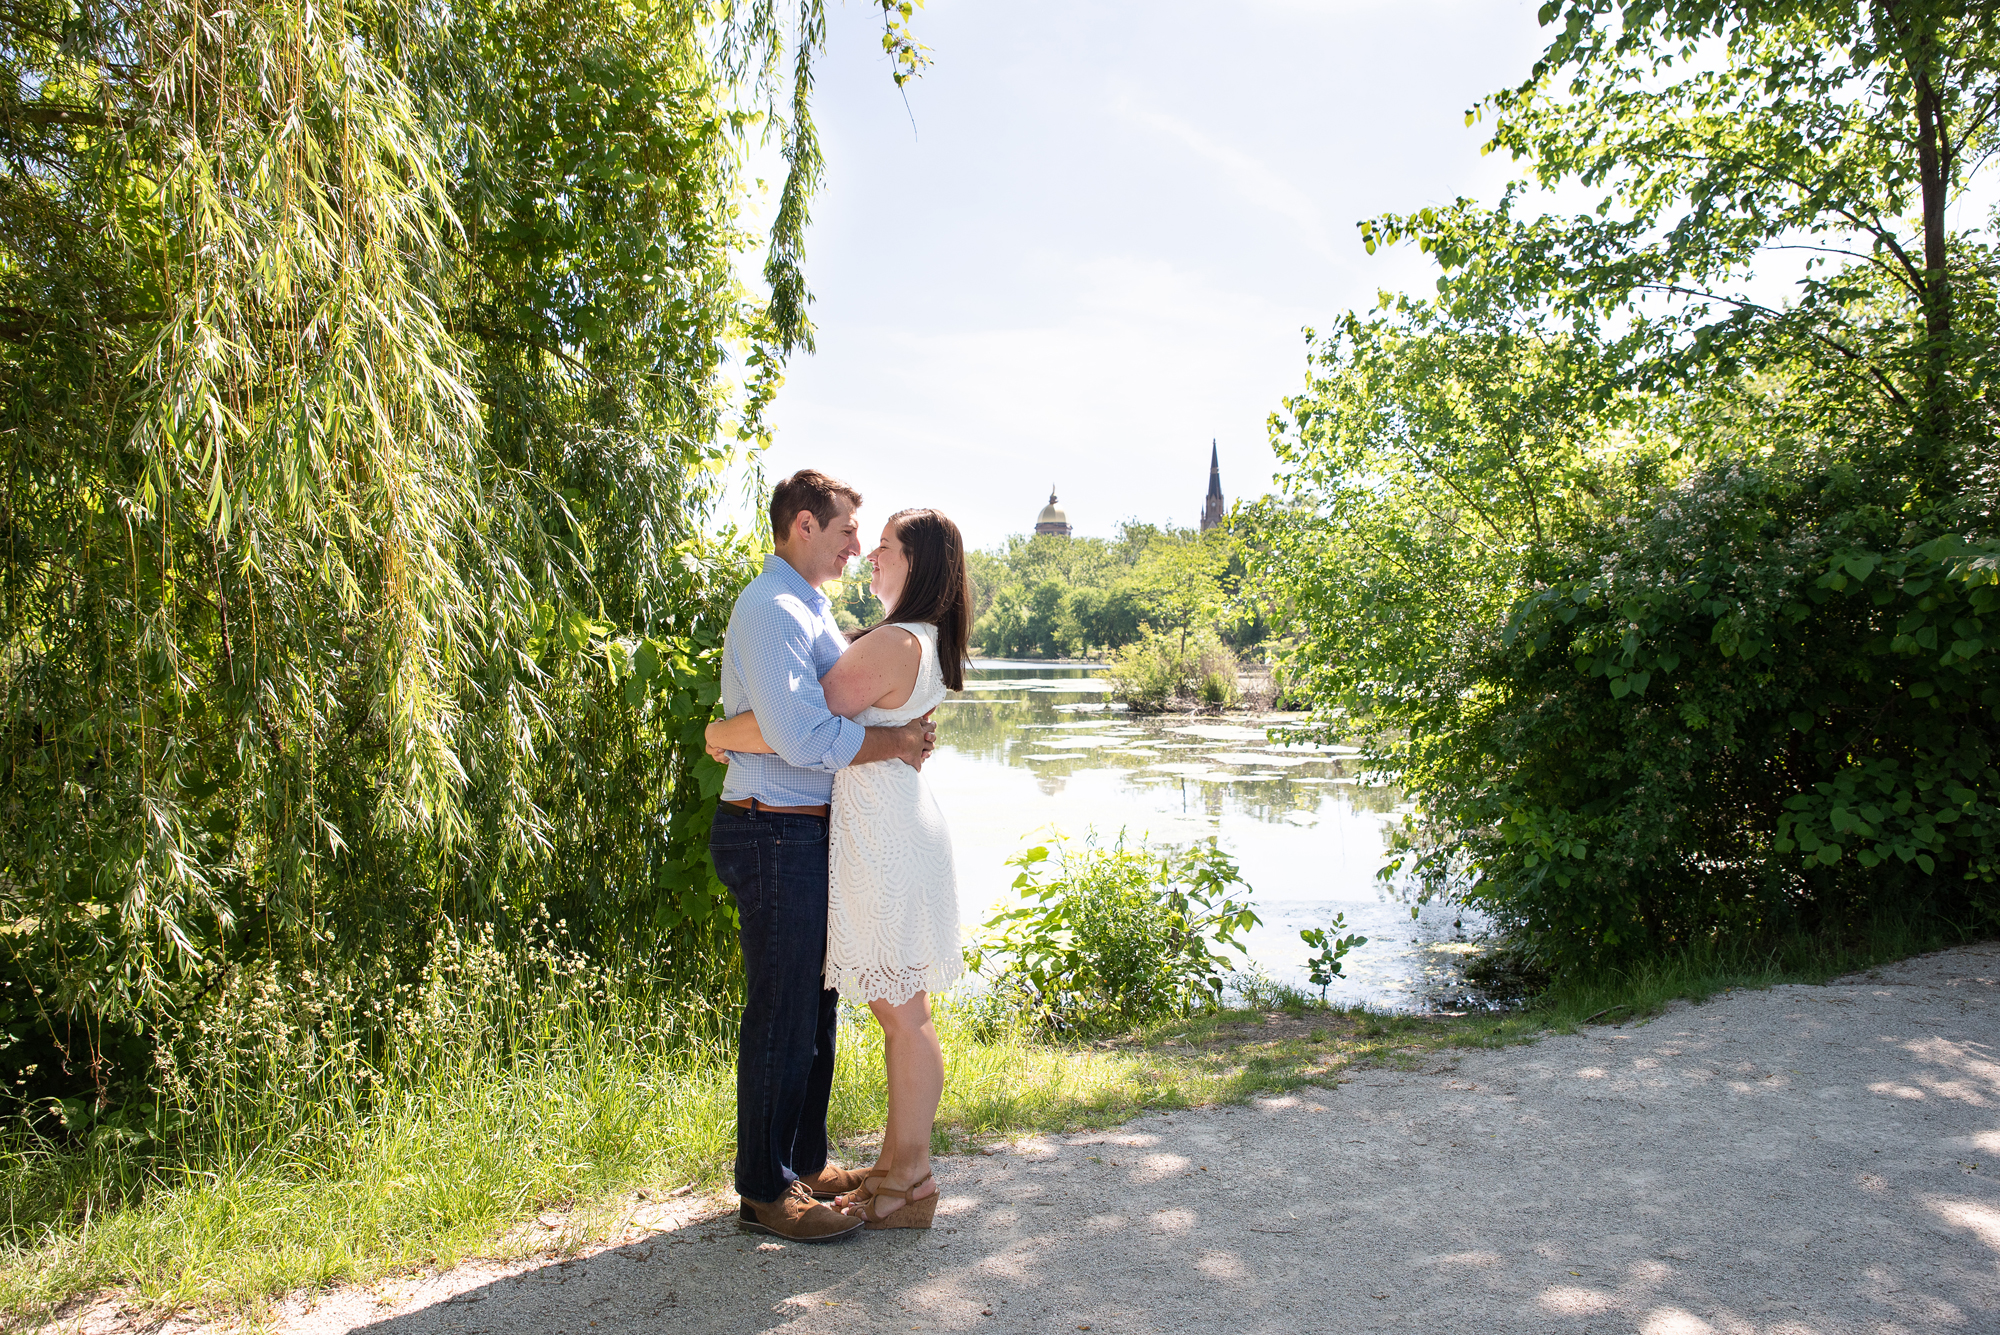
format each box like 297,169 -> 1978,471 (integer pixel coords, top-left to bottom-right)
1456,466 -> 2000,965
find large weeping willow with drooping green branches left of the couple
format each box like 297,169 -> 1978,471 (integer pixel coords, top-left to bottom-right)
0,0 -> 904,1103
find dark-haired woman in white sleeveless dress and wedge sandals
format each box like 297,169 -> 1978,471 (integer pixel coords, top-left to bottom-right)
708,510 -> 972,1229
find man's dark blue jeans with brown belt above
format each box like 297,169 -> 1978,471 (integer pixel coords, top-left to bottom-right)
708,801 -> 840,1201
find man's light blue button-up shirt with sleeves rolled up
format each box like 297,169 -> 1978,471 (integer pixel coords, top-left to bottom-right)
722,556 -> 868,807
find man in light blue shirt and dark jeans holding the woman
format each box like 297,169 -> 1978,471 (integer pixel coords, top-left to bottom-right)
708,470 -> 934,1243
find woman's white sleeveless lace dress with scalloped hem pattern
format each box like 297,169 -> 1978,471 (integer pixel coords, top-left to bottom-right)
826,622 -> 966,1005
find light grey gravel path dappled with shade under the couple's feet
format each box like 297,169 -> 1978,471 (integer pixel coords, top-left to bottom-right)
129,945 -> 2000,1335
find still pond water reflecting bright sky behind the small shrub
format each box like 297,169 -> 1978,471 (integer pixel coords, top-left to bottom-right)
924,660 -> 1482,1011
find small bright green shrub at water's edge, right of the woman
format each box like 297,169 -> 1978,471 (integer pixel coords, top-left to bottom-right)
980,835 -> 1258,1035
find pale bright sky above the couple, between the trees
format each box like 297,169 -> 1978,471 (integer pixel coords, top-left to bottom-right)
736,0 -> 1544,548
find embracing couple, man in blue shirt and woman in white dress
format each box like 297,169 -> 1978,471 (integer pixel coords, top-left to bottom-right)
708,470 -> 972,1243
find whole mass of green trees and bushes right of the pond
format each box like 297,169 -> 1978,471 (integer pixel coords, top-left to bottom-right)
1264,0 -> 2000,977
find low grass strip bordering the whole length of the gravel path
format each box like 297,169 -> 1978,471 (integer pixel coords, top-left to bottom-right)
0,927 -> 1976,1329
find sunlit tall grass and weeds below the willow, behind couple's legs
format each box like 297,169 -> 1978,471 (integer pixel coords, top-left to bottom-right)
0,939 -> 1222,1315
